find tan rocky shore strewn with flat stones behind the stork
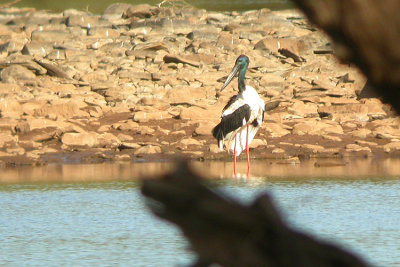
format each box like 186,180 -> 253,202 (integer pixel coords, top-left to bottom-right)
0,4 -> 400,166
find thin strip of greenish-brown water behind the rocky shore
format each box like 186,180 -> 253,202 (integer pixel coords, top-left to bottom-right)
13,0 -> 293,14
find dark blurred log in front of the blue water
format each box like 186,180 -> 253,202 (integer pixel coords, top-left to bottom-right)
142,163 -> 367,267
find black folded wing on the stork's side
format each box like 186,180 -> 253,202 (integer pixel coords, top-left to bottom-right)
212,104 -> 251,140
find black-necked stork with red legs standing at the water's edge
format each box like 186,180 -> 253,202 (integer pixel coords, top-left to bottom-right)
212,55 -> 265,176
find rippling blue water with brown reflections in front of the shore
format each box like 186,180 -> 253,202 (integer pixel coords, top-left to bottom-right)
0,160 -> 400,266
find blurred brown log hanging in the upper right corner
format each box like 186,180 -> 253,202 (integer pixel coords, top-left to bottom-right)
294,0 -> 400,113
